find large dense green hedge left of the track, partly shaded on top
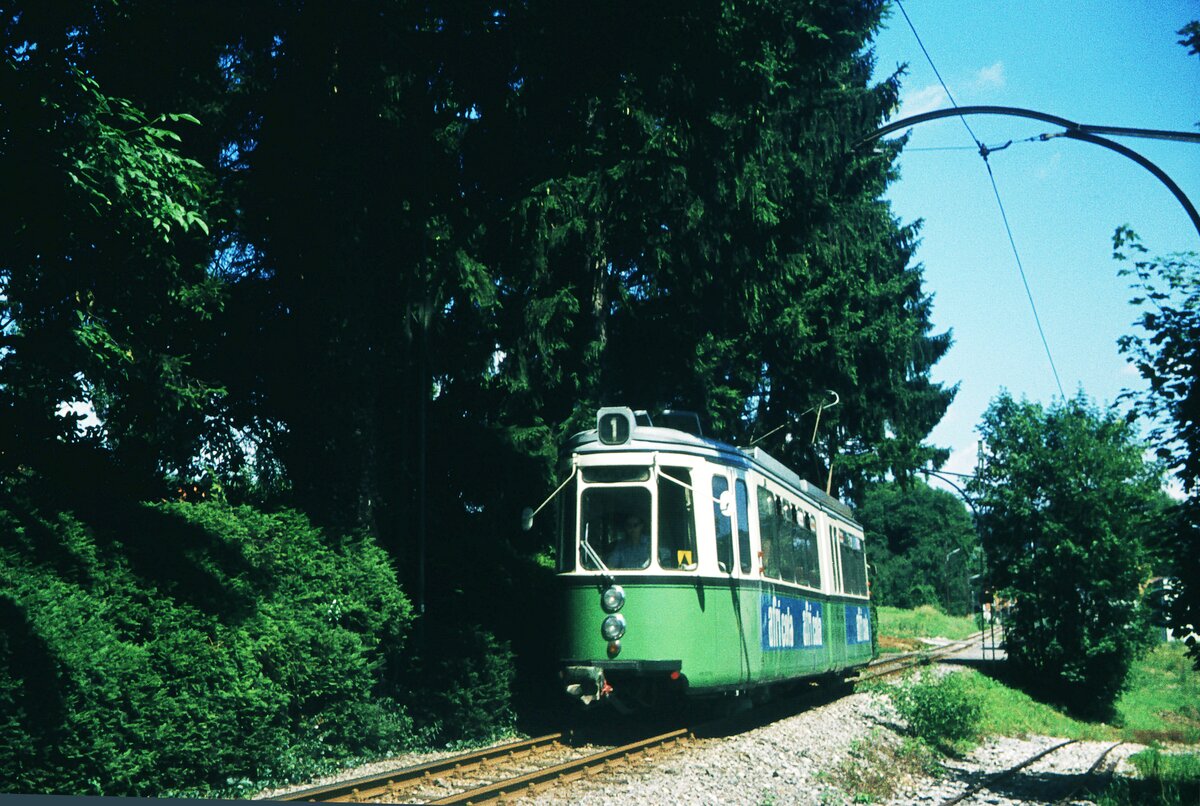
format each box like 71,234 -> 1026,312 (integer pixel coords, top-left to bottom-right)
0,491 -> 414,795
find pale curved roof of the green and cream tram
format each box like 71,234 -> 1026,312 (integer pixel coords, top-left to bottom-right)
564,425 -> 857,523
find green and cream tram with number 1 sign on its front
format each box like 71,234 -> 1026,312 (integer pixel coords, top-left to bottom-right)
557,409 -> 872,708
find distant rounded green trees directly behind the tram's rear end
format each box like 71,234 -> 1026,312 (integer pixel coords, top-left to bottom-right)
856,480 -> 979,615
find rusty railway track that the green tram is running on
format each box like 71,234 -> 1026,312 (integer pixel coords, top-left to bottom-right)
271,634 -> 993,805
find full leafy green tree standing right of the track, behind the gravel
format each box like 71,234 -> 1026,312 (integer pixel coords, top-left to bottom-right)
970,393 -> 1162,712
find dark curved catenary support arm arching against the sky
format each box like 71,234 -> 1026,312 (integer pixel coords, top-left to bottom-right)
857,107 -> 1200,242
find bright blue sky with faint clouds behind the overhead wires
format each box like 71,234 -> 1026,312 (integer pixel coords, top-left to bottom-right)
875,0 -> 1200,484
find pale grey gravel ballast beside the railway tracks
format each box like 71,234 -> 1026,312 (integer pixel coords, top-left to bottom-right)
260,667 -> 1142,806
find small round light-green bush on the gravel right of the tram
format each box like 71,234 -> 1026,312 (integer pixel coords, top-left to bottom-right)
888,673 -> 983,754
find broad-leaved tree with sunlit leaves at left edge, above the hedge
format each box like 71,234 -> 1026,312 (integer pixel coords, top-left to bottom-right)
0,4 -> 223,476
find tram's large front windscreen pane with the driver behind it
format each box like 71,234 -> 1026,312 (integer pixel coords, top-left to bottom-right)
580,487 -> 650,570
